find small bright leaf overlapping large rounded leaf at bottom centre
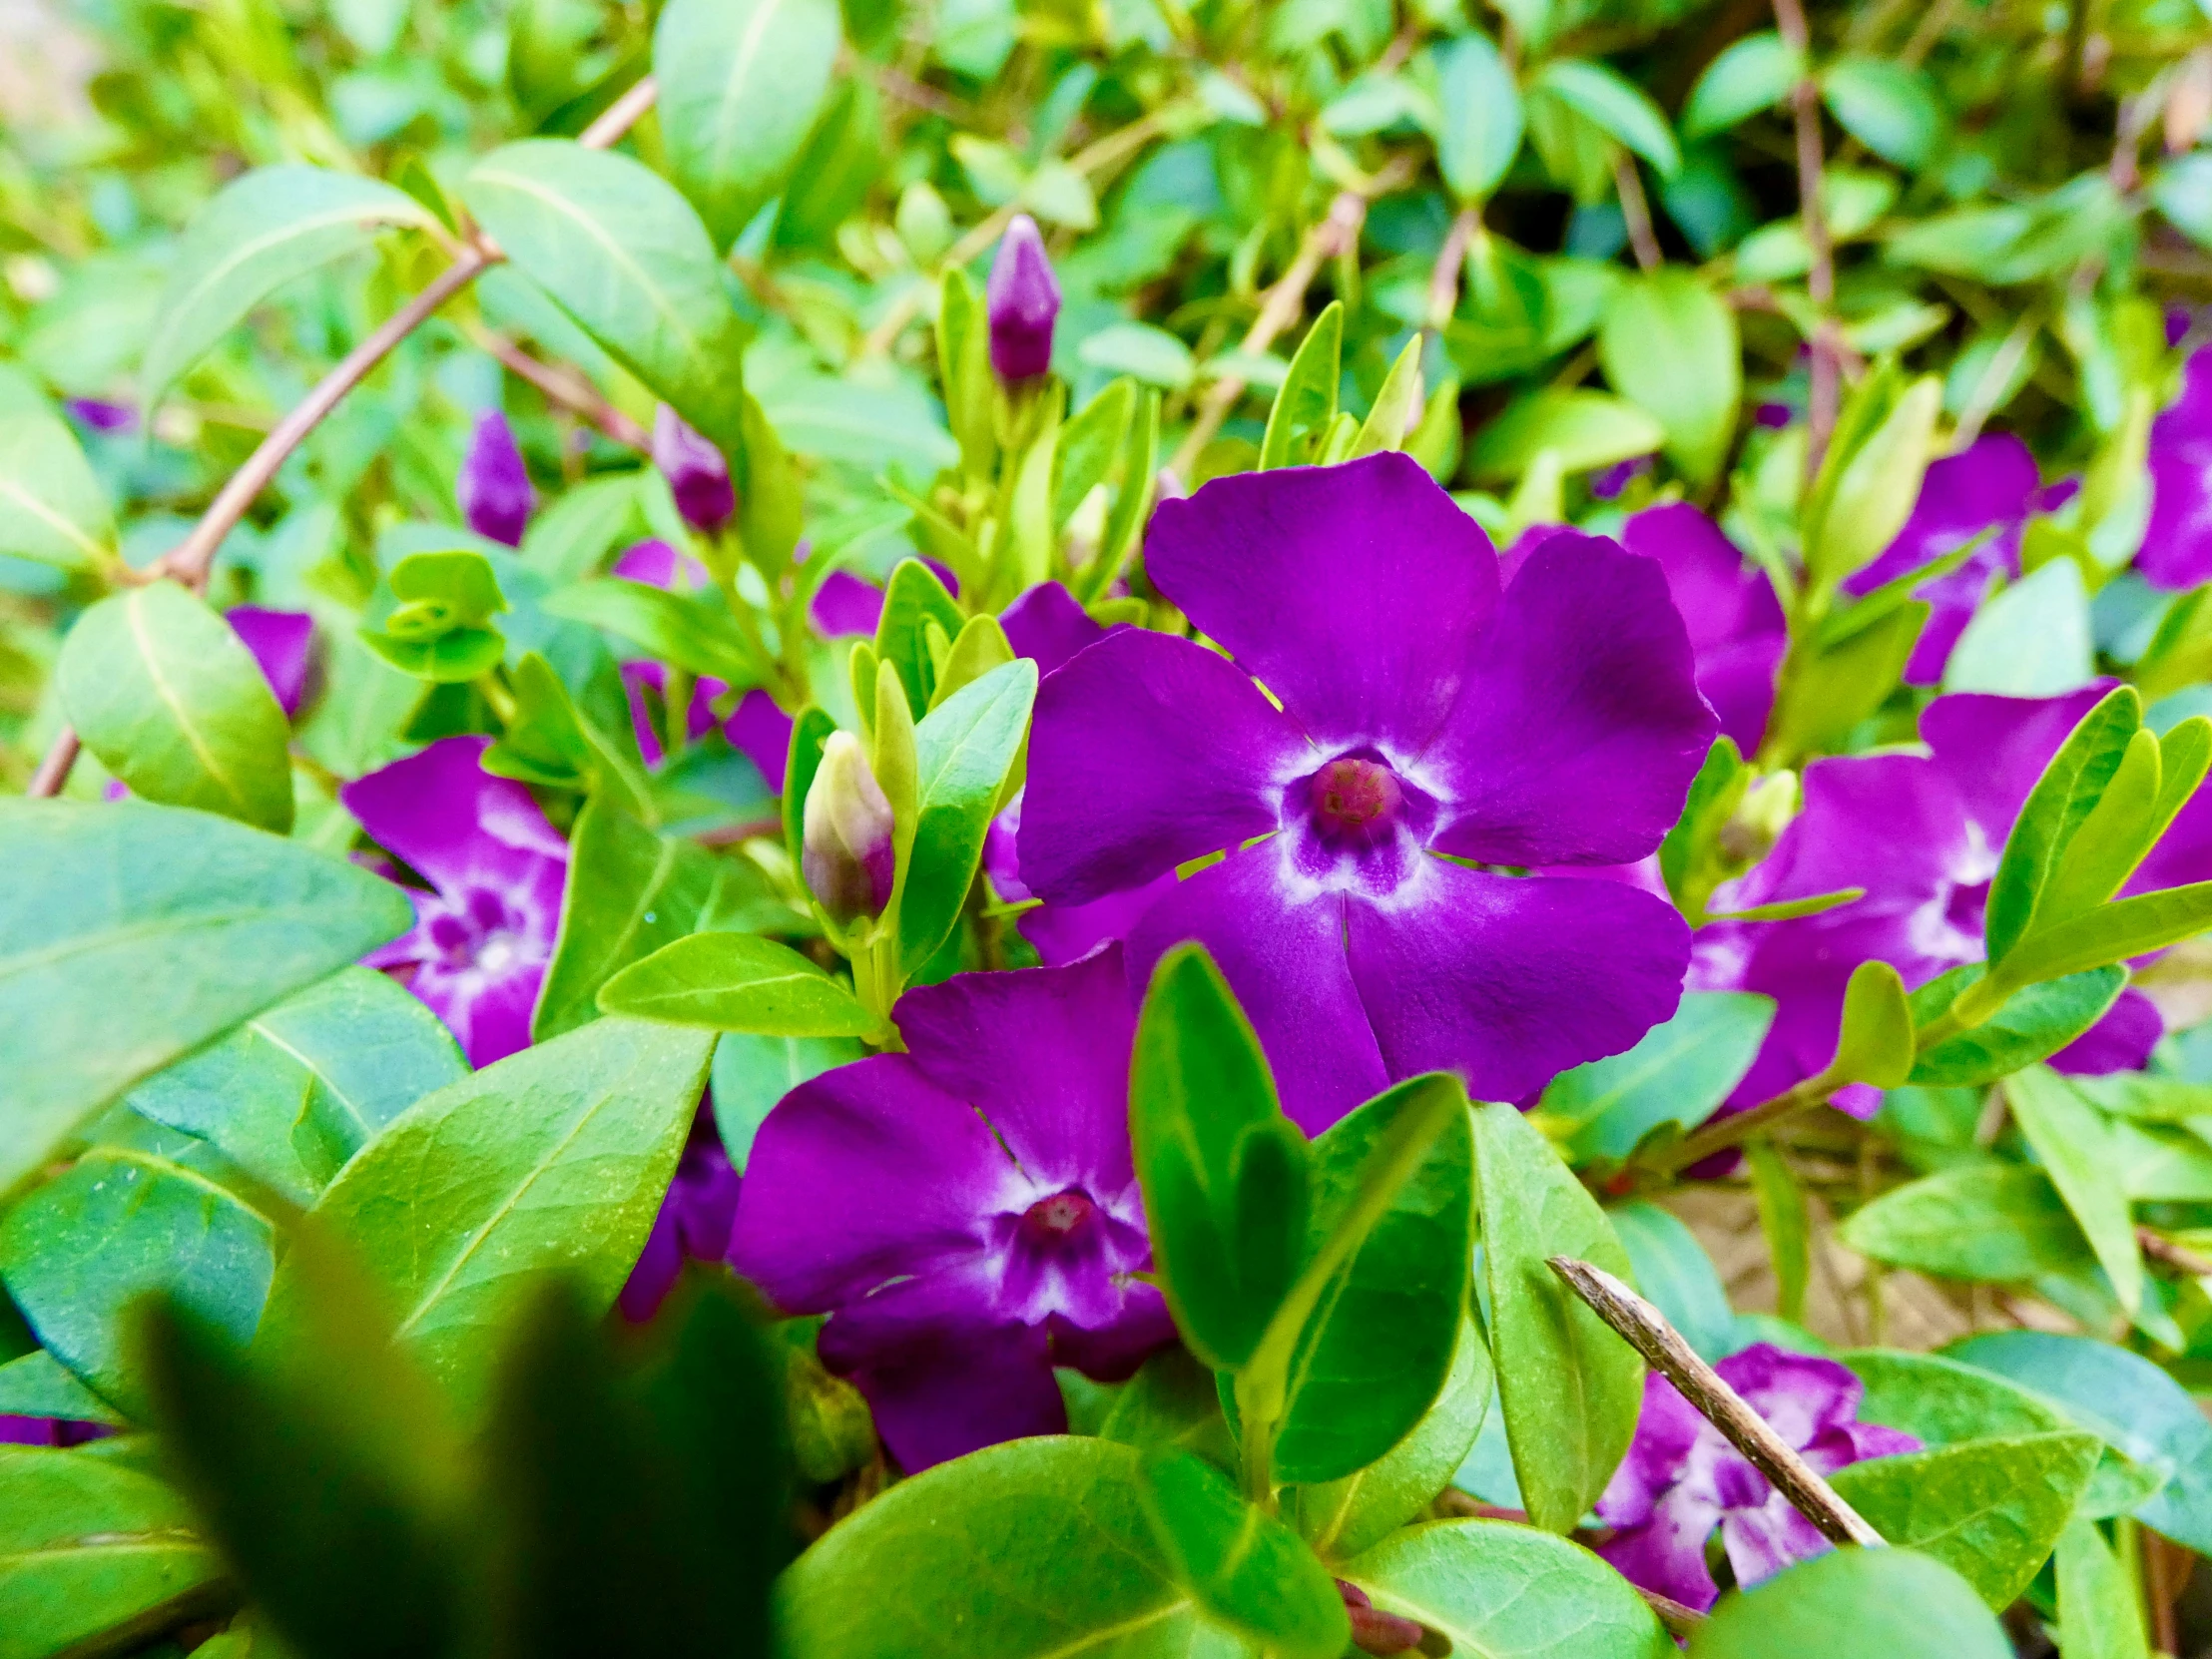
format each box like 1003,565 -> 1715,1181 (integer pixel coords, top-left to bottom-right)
1139,1451 -> 1352,1659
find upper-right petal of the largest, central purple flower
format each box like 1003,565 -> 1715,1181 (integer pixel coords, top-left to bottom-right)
1424,533 -> 1719,864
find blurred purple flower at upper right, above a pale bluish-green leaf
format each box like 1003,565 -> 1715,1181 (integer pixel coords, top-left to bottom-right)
1843,433 -> 2043,686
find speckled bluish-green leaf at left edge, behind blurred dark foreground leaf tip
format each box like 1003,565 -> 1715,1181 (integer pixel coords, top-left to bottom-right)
0,1148 -> 275,1422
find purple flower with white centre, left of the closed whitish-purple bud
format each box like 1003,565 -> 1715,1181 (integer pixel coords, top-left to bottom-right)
338,737 -> 569,1066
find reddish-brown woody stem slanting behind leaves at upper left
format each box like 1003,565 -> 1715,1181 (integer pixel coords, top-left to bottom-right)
29,75 -> 655,797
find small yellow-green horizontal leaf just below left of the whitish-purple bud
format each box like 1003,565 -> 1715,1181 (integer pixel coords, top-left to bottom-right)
600,933 -> 880,1037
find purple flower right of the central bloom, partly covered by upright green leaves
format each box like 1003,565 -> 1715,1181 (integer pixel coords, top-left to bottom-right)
1690,686 -> 2176,1117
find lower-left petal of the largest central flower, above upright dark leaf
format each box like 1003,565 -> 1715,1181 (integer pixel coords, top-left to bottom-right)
1123,848 -> 1389,1135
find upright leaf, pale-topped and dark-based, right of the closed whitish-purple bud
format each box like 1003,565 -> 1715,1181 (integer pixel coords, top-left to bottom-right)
893,663 -> 1037,973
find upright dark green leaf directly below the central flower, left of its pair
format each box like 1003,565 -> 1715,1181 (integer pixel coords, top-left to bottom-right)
1128,944 -> 1310,1370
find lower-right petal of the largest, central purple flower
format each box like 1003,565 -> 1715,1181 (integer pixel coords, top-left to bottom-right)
1345,858 -> 1690,1099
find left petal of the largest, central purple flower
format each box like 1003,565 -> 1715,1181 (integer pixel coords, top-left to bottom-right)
1017,628 -> 1309,904
